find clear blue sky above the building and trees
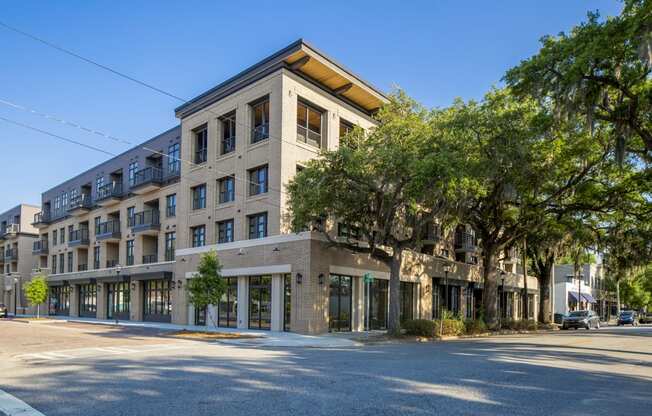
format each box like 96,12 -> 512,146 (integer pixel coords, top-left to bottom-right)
0,0 -> 622,212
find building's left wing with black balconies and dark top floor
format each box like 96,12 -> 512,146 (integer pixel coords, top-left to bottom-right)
34,127 -> 181,320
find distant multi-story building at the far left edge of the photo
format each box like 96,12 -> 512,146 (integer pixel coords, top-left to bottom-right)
0,204 -> 41,314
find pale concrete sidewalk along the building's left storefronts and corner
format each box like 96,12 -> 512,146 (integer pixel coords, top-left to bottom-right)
18,315 -> 363,348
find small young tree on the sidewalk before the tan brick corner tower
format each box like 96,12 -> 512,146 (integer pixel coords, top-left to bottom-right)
186,251 -> 226,326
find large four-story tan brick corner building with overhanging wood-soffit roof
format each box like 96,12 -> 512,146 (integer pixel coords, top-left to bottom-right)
31,40 -> 537,333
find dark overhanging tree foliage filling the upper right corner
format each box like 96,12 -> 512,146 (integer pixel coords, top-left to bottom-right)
505,0 -> 652,163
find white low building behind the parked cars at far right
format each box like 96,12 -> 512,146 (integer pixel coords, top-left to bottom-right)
553,264 -> 611,320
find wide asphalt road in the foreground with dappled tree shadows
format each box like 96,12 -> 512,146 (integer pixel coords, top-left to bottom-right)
0,321 -> 652,416
